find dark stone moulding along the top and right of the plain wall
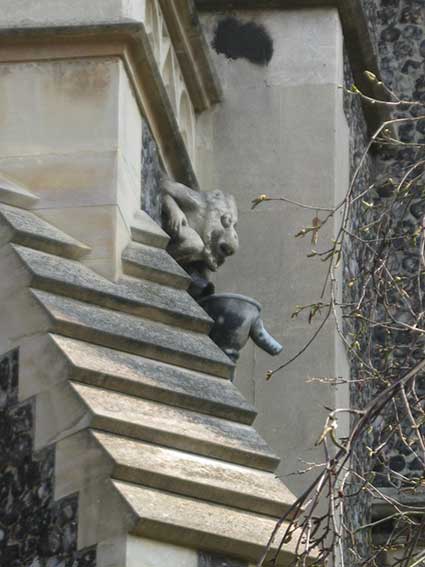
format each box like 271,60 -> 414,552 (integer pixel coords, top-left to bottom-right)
195,0 -> 389,131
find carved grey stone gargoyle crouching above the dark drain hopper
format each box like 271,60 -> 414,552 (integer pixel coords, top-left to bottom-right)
161,177 -> 239,273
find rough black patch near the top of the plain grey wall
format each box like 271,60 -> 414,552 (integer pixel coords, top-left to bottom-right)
212,17 -> 273,65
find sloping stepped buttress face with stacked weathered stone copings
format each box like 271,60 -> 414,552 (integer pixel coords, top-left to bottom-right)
0,181 -> 293,567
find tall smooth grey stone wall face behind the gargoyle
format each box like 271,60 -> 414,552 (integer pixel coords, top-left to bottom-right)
198,8 -> 349,494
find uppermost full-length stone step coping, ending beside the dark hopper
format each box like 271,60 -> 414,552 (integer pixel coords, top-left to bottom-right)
12,244 -> 212,333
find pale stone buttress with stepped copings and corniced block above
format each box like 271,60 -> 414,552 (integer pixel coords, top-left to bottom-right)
0,2 -> 294,567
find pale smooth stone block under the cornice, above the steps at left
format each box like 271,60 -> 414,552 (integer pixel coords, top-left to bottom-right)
0,56 -> 142,279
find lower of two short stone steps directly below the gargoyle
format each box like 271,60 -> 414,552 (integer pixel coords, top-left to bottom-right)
122,243 -> 191,289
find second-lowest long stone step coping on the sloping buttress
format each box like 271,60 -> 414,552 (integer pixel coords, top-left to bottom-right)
92,431 -> 295,517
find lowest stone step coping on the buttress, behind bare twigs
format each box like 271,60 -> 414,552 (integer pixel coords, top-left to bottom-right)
112,481 -> 296,566
